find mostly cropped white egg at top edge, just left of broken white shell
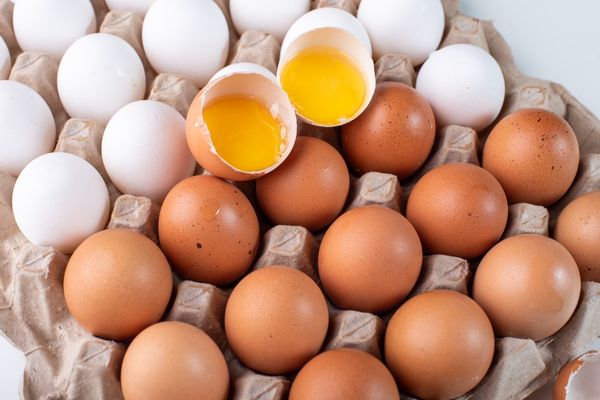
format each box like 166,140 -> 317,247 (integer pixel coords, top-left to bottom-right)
229,0 -> 310,41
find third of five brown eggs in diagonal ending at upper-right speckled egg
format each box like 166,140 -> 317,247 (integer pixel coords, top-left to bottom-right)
319,206 -> 423,313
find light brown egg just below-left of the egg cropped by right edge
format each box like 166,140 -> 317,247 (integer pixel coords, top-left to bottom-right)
473,235 -> 581,341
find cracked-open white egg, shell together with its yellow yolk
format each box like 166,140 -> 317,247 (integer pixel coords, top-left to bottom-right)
277,7 -> 375,127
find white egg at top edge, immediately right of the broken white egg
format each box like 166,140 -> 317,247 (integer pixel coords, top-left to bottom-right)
357,0 -> 444,65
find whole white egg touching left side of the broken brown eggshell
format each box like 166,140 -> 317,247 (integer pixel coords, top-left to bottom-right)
102,100 -> 196,204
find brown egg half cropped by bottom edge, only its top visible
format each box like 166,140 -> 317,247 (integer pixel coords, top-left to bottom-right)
289,349 -> 400,400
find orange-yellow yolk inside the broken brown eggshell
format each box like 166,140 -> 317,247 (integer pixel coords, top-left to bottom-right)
202,96 -> 283,172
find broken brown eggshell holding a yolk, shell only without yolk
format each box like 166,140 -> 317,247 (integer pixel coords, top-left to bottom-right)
186,63 -> 297,181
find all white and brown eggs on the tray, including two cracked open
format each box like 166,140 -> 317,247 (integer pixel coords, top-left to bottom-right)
0,0 -> 600,400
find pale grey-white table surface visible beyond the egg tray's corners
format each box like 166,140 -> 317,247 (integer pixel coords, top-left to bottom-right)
0,0 -> 600,400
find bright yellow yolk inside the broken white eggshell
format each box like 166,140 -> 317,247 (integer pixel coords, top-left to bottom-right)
281,47 -> 366,126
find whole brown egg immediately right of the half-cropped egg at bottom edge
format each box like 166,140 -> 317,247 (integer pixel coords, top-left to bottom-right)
385,290 -> 494,400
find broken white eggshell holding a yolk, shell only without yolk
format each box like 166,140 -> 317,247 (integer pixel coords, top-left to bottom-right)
277,7 -> 376,127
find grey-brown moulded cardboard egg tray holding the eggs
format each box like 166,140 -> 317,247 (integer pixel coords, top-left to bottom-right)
0,0 -> 600,400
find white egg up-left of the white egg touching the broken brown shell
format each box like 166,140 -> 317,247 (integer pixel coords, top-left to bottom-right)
58,33 -> 146,124
